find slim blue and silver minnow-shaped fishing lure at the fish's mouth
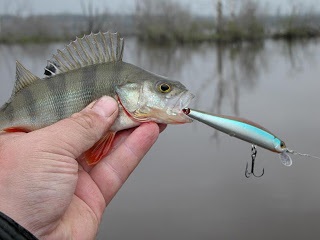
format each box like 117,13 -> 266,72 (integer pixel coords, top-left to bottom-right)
183,108 -> 320,166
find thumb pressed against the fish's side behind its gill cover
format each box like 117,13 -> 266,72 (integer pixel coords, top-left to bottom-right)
38,96 -> 118,158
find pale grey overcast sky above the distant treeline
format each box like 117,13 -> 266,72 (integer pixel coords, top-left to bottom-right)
0,0 -> 320,15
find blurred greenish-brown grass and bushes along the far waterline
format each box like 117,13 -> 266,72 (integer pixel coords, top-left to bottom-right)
0,21 -> 320,45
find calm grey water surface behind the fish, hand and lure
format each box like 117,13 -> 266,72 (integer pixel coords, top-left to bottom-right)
0,39 -> 320,240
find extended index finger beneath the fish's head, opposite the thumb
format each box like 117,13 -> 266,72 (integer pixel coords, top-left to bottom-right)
90,122 -> 159,204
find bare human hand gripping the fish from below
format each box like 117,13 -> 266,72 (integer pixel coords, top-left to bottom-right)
0,97 -> 165,239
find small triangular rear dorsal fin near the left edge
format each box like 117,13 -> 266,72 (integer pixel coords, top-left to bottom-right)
12,61 -> 40,95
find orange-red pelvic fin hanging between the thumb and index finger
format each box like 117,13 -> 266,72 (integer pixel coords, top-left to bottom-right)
84,132 -> 116,165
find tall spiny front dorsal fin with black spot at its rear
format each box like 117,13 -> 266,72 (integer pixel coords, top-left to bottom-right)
45,32 -> 124,76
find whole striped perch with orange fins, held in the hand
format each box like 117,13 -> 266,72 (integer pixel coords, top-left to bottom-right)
0,32 -> 193,164
